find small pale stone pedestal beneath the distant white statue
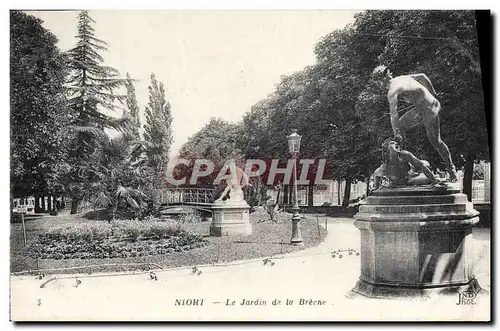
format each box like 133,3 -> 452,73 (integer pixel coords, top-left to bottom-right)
210,200 -> 252,236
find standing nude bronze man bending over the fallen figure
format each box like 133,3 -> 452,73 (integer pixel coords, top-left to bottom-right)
372,66 -> 457,182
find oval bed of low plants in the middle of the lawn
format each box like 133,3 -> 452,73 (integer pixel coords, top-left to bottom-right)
27,220 -> 207,259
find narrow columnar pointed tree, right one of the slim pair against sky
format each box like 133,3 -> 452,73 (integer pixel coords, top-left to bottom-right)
144,73 -> 173,183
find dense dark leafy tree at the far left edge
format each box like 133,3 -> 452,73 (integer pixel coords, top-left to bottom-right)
10,11 -> 69,201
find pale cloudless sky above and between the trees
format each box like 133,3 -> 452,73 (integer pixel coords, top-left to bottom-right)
28,10 -> 356,156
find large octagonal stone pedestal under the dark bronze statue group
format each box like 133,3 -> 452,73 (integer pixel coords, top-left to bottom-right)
351,185 -> 479,298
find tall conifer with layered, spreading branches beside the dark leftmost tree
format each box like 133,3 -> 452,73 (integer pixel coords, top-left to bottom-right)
67,10 -> 128,213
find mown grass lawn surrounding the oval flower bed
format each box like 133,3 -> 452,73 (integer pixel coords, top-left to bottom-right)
10,210 -> 326,274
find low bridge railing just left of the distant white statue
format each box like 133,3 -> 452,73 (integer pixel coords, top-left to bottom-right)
159,188 -> 215,205
